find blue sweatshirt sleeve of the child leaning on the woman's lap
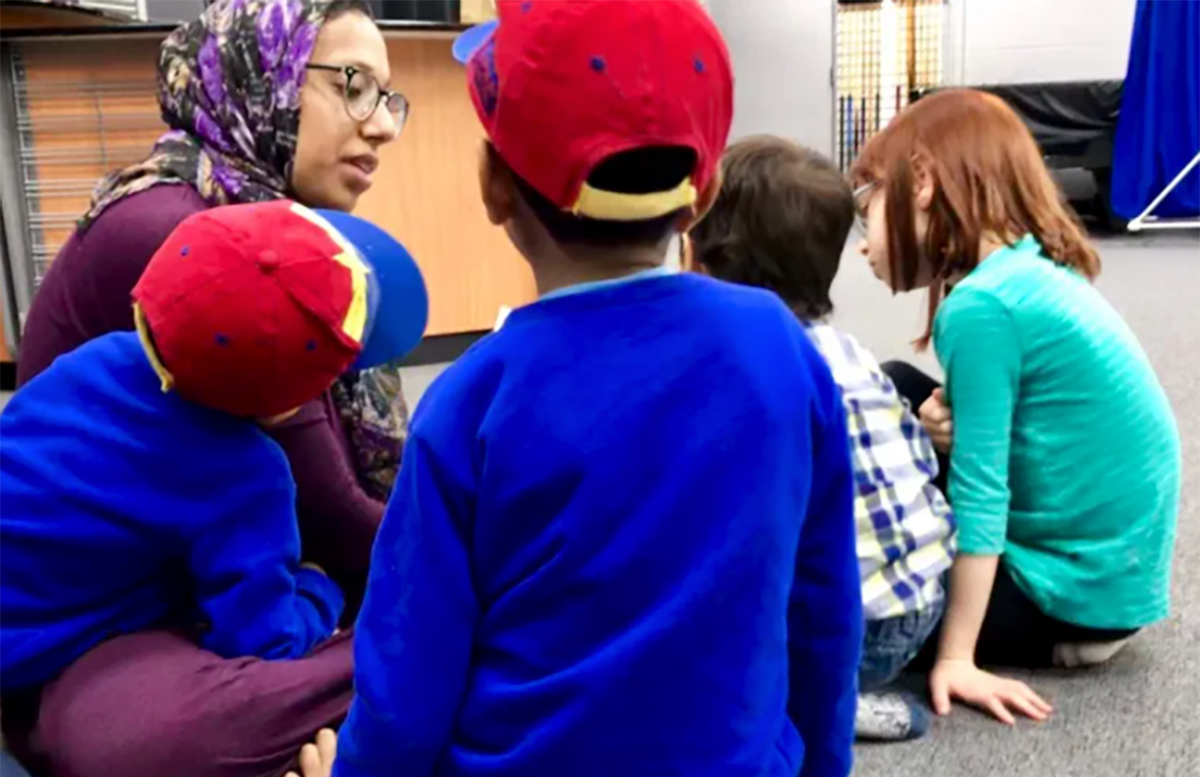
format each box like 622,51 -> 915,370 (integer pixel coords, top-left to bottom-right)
190,484 -> 343,659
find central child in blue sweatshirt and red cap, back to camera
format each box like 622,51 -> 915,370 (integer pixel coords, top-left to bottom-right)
331,0 -> 863,777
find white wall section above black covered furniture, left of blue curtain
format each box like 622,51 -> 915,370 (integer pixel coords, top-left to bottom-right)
950,0 -> 1138,85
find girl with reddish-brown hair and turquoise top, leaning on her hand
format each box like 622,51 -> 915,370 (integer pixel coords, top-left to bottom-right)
853,90 -> 1181,724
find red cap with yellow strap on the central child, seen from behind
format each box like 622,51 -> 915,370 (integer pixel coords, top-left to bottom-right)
455,0 -> 733,221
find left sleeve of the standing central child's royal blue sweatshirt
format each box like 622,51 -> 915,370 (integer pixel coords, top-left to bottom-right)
334,434 -> 479,777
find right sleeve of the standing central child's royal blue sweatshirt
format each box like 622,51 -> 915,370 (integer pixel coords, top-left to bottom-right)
787,371 -> 863,777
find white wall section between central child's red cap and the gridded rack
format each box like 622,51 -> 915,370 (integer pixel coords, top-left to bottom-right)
707,0 -> 834,155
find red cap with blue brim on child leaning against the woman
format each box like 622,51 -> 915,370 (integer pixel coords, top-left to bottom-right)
133,200 -> 428,417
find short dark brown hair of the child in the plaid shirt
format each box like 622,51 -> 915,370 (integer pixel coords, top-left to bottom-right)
690,135 -> 854,320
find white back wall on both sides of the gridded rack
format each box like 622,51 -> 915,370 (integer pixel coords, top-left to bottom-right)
707,0 -> 1138,153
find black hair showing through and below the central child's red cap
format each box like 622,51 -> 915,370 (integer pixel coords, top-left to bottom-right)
504,146 -> 696,248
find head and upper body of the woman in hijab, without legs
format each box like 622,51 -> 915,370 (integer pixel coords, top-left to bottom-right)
18,0 -> 408,622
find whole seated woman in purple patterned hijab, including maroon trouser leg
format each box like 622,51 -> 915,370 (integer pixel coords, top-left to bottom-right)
4,0 -> 407,777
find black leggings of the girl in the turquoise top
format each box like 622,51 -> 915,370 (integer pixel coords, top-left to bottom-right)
883,362 -> 1138,669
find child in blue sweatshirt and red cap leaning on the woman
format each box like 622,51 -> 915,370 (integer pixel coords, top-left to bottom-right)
0,201 -> 425,773
